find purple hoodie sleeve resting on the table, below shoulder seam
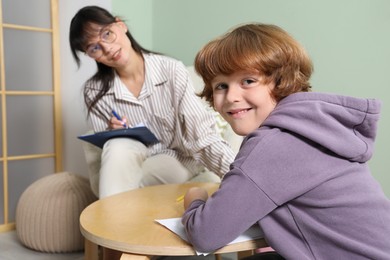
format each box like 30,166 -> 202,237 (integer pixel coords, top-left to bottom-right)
182,165 -> 276,252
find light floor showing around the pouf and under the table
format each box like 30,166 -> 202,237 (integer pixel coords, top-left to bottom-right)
0,231 -> 236,260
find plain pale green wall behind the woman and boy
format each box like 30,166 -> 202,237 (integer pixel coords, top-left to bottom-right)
112,0 -> 390,197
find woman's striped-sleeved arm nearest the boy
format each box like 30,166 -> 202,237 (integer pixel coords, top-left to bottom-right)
175,65 -> 235,177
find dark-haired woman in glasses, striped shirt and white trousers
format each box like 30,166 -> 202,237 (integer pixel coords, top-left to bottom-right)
69,6 -> 234,198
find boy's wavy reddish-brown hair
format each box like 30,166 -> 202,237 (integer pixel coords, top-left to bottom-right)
195,24 -> 313,106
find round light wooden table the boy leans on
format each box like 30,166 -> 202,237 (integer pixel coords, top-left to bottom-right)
80,183 -> 266,260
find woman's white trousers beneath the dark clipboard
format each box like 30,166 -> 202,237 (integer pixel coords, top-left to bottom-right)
99,138 -> 193,198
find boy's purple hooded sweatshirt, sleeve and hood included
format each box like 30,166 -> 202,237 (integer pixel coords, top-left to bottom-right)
182,92 -> 390,260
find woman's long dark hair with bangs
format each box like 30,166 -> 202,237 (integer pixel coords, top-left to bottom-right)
69,6 -> 152,116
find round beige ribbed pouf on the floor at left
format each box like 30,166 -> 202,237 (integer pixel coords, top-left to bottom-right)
16,172 -> 96,253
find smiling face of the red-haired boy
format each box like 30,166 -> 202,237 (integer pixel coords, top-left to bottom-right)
211,71 -> 276,136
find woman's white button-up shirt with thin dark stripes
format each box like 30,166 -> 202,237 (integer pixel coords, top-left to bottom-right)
85,54 -> 234,177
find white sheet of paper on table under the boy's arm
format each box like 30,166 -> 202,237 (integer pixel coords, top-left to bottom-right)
156,218 -> 264,256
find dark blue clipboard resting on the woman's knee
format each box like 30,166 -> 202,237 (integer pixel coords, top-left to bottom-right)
77,126 -> 159,148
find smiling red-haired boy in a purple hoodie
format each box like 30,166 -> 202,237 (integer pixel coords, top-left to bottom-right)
182,24 -> 390,260
